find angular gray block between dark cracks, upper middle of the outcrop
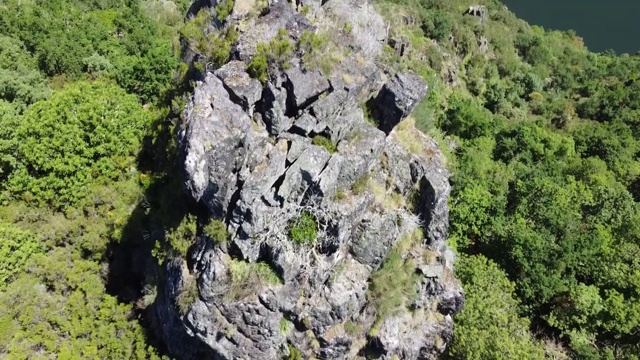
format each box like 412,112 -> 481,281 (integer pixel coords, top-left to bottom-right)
285,67 -> 329,110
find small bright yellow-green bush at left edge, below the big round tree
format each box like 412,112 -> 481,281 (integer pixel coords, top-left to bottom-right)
0,223 -> 44,290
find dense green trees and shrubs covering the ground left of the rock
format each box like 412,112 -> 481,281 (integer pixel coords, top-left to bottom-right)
0,0 -> 194,359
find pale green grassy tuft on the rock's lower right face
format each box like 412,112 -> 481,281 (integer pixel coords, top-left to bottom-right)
367,247 -> 419,320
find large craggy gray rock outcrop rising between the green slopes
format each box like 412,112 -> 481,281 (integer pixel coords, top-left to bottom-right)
157,0 -> 464,360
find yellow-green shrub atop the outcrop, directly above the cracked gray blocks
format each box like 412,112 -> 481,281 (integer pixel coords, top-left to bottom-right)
247,29 -> 294,83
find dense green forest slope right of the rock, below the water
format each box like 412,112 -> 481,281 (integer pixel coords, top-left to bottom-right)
378,0 -> 640,359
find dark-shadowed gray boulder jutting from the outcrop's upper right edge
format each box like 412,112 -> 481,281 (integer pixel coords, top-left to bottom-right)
376,72 -> 427,134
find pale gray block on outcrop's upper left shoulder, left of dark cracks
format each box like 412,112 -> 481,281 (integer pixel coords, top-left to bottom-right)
215,61 -> 262,109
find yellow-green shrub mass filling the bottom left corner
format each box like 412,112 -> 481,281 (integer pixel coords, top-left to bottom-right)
0,248 -> 158,359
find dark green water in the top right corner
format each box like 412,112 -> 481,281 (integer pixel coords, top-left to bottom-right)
502,0 -> 640,54
